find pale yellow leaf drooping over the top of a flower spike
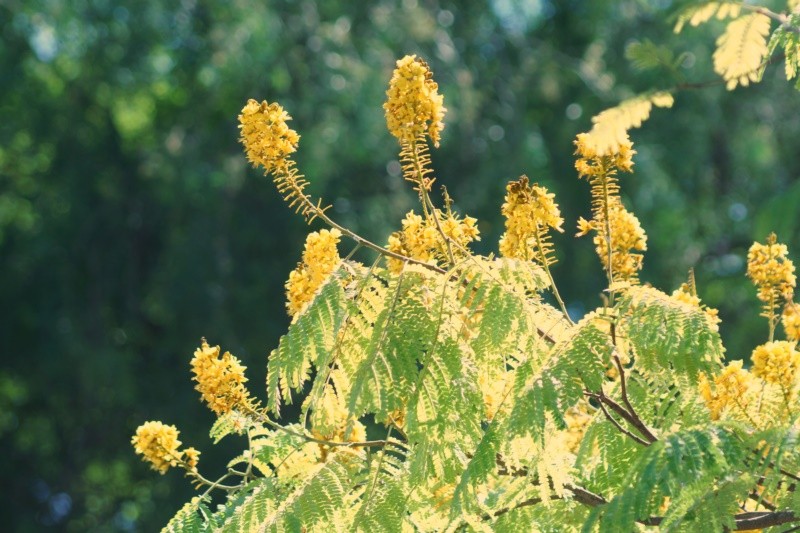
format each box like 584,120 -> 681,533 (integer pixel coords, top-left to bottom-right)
585,91 -> 673,155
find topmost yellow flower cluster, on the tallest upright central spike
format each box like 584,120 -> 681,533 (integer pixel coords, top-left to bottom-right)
383,55 -> 447,147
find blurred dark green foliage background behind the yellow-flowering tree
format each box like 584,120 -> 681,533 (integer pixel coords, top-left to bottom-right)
0,0 -> 800,531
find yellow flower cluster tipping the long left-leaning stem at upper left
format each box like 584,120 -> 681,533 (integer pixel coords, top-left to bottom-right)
239,98 -> 300,172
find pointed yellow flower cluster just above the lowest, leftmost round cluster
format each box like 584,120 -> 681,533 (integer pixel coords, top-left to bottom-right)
191,339 -> 249,415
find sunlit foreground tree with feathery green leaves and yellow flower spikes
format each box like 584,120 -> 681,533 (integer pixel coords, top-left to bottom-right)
132,2 -> 800,531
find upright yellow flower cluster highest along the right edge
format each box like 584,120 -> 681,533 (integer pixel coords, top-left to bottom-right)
747,233 -> 796,307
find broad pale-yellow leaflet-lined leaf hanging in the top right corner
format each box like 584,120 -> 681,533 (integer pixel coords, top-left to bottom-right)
714,13 -> 770,91
